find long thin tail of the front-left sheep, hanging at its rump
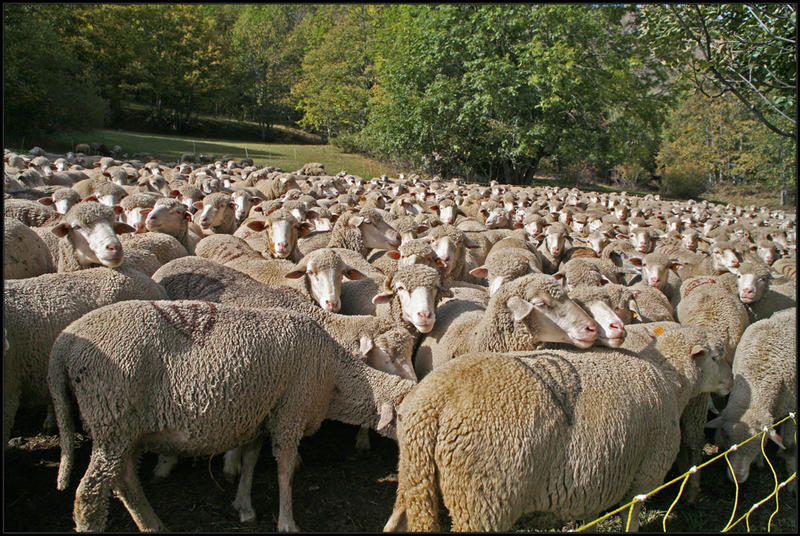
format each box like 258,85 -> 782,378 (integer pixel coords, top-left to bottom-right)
47,344 -> 75,491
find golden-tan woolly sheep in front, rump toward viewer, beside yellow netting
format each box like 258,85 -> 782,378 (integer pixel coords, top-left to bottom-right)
384,328 -> 731,532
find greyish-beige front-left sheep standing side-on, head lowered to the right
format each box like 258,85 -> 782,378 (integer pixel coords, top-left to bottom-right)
48,300 -> 414,531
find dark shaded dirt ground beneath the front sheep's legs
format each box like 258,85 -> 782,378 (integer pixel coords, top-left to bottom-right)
3,406 -> 797,533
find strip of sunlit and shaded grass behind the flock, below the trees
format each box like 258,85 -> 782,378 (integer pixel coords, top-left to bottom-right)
27,129 -> 398,180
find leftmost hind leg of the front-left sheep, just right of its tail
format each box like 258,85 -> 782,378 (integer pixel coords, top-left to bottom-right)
72,446 -> 123,532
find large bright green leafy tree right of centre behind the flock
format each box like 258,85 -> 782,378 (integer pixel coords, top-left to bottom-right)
365,4 -> 664,183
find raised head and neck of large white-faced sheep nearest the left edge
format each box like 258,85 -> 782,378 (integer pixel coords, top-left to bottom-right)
52,201 -> 133,272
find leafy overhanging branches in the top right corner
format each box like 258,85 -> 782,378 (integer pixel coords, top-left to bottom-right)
643,4 -> 797,140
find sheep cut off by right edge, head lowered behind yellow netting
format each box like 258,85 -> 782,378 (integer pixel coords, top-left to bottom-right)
706,307 -> 797,486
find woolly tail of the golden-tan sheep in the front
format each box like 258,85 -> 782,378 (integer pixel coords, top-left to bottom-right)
398,410 -> 440,532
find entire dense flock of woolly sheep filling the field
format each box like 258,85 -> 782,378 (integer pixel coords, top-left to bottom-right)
3,144 -> 796,531
